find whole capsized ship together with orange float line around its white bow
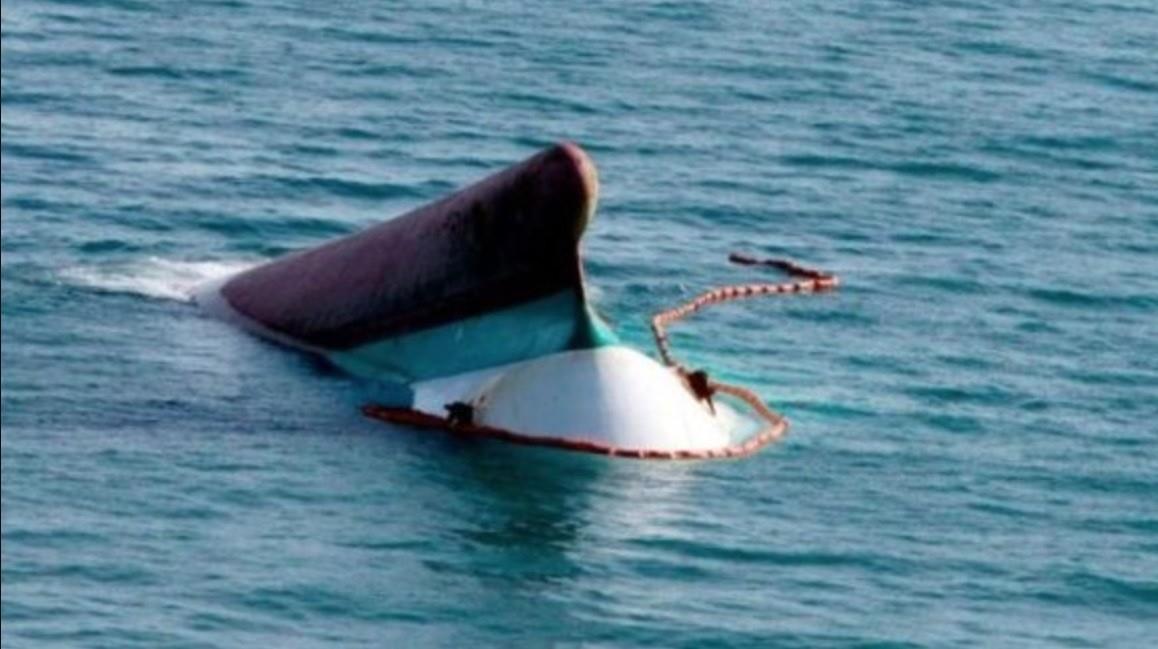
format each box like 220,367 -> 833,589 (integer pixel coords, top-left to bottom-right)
197,143 -> 836,459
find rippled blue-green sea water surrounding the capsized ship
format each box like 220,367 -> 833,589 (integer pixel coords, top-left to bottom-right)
0,0 -> 1158,649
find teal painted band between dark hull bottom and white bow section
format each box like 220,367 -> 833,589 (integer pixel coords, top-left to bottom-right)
329,291 -> 618,382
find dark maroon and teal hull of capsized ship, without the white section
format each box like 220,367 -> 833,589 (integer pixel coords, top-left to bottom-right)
199,144 -> 614,382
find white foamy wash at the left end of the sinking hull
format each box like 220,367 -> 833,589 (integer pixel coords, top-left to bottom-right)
61,257 -> 255,301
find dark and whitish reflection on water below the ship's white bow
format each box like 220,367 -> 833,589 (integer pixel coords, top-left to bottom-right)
416,438 -> 696,626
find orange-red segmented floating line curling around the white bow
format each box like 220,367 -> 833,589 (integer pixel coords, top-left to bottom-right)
362,253 -> 840,460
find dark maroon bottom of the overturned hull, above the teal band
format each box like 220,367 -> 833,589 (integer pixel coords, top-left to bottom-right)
221,144 -> 598,350
